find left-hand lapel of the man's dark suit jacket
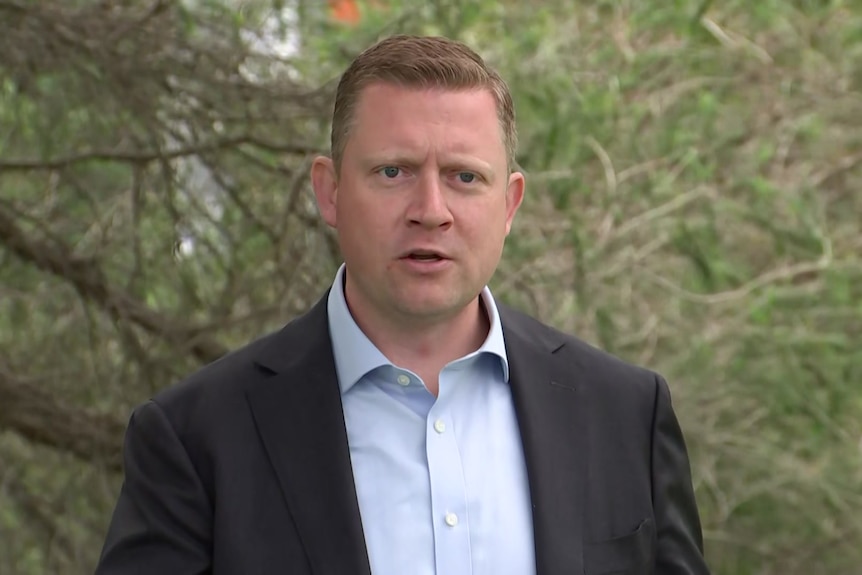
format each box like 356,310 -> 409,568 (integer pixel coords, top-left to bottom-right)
247,297 -> 371,575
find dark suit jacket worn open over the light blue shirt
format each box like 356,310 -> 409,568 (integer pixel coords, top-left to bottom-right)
96,298 -> 708,575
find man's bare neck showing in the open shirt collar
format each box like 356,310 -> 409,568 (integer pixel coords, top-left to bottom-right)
348,296 -> 490,396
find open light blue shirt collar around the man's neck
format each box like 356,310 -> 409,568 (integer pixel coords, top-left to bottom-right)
326,264 -> 509,394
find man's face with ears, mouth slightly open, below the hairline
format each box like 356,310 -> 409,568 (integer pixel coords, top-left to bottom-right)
312,83 -> 524,325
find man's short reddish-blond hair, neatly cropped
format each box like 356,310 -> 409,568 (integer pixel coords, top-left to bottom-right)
331,34 -> 518,170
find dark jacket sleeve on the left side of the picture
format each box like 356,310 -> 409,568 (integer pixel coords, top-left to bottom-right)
96,401 -> 212,575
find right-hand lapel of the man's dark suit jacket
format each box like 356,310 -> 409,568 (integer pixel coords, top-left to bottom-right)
500,306 -> 589,575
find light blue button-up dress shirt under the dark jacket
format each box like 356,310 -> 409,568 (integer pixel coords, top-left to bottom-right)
327,265 -> 536,575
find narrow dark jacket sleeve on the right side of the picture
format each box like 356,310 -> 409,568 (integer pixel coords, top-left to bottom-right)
652,376 -> 709,575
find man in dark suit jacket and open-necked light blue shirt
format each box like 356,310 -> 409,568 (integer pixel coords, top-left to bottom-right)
97,36 -> 707,575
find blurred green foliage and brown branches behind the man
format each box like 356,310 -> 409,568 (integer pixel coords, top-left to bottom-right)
0,0 -> 862,575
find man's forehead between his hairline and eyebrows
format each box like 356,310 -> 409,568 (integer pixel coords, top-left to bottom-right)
348,82 -> 505,159
